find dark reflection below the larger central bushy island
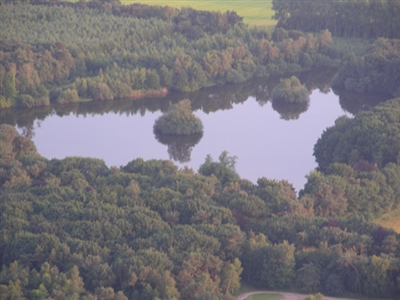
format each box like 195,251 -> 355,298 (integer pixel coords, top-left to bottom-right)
154,132 -> 203,163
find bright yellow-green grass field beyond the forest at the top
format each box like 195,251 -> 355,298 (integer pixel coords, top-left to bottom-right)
121,0 -> 276,27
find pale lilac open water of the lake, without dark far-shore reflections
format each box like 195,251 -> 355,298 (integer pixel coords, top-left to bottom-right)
20,90 -> 345,191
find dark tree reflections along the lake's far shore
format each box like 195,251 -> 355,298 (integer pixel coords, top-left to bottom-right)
0,68 -> 336,135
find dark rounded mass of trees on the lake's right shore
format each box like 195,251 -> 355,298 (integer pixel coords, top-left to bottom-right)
314,98 -> 400,171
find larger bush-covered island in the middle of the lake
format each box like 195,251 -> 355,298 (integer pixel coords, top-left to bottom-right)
154,99 -> 203,135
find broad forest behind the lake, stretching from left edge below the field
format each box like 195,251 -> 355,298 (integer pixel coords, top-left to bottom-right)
0,1 -> 337,107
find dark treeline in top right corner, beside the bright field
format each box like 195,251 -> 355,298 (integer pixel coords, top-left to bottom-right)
272,0 -> 400,39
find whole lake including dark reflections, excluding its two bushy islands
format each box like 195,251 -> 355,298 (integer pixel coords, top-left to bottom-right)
2,69 -> 358,192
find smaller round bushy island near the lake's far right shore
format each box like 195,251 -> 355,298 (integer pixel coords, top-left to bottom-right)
271,76 -> 309,103
